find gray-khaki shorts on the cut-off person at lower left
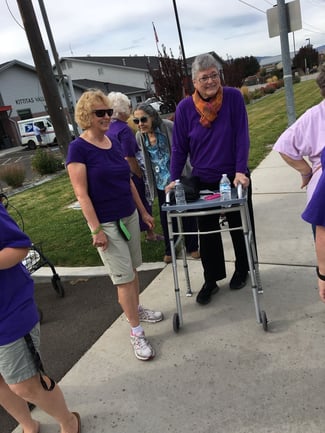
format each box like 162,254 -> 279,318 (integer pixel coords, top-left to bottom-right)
0,323 -> 40,385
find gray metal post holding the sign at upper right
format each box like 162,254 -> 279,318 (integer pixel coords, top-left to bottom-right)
277,0 -> 296,126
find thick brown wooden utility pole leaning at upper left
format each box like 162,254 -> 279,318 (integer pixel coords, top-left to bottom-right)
17,0 -> 71,156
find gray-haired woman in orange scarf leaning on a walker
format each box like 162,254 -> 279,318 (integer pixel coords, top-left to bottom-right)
166,54 -> 255,305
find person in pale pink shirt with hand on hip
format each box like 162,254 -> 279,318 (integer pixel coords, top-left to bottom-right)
273,64 -> 325,230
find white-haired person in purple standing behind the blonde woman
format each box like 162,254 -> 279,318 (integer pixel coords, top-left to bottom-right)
106,92 -> 164,241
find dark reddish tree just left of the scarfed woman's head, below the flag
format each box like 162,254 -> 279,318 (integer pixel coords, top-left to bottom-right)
148,46 -> 185,104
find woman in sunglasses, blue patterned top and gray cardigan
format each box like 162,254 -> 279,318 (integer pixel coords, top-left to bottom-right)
133,102 -> 200,263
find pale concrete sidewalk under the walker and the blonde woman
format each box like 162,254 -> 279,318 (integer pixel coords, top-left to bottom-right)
15,152 -> 325,433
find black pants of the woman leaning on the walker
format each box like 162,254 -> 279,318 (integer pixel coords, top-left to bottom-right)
198,177 -> 255,284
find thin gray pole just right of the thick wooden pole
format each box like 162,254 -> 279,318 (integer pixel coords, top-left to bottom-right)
38,0 -> 79,137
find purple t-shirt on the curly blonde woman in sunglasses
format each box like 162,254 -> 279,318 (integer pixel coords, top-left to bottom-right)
66,134 -> 135,223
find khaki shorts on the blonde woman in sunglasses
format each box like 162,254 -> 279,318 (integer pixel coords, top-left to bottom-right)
97,210 -> 142,286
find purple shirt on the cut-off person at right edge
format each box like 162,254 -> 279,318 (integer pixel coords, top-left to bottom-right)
301,148 -> 325,227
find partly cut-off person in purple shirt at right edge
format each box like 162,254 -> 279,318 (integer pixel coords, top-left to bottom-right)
302,149 -> 325,302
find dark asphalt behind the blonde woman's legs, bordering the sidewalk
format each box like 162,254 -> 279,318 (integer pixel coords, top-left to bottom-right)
0,269 -> 160,433
